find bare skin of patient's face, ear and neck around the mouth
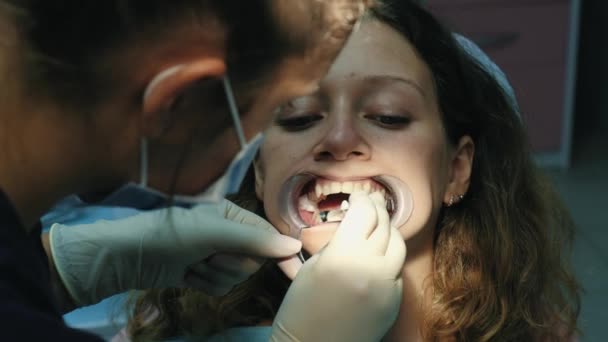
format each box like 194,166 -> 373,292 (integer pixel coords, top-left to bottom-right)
256,20 -> 474,341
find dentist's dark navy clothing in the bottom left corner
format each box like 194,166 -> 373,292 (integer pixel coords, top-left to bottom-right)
0,190 -> 101,341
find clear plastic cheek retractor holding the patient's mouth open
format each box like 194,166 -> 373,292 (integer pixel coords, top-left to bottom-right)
278,174 -> 414,262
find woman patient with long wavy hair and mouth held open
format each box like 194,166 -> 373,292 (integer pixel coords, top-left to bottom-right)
122,0 -> 579,341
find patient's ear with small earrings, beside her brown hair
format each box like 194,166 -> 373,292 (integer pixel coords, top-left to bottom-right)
443,135 -> 475,206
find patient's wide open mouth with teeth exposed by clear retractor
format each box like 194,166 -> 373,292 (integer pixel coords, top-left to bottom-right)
279,174 -> 412,235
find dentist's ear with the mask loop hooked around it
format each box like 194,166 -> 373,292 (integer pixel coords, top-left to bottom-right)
142,57 -> 226,136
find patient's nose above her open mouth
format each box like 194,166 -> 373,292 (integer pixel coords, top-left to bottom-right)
314,113 -> 370,161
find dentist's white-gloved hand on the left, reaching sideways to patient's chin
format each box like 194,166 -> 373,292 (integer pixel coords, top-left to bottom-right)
49,200 -> 301,306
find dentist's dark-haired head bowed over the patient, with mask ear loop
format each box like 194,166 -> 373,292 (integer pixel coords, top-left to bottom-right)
0,0 -> 366,223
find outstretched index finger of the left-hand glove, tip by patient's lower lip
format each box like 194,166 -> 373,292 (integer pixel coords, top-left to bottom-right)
207,221 -> 302,258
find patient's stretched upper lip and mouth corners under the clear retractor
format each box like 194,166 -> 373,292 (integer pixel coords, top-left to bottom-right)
279,173 -> 413,234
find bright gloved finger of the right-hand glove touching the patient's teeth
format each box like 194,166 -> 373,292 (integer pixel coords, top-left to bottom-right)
328,192 -> 377,249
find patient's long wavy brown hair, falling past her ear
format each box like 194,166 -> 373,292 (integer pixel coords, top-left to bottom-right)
124,0 -> 580,341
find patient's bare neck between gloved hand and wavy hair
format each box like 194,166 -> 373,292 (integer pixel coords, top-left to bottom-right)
383,230 -> 433,342
